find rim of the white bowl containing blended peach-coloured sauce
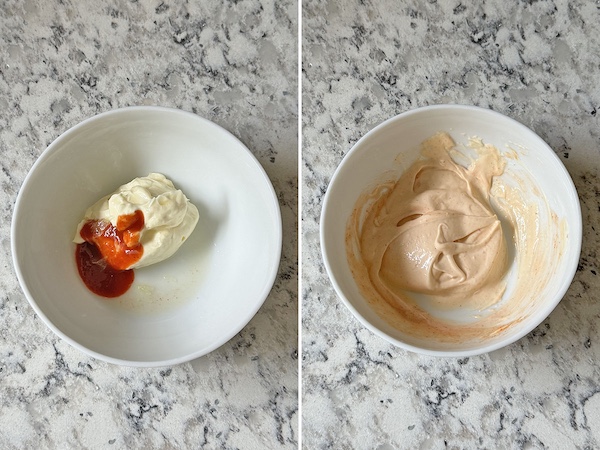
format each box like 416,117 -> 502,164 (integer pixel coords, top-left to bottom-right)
319,104 -> 583,357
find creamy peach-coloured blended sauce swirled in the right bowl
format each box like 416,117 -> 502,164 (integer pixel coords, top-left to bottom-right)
346,133 -> 538,343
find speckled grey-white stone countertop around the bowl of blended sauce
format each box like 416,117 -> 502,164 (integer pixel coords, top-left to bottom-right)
301,0 -> 600,450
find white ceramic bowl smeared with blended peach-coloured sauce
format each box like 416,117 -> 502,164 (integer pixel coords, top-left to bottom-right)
321,105 -> 582,356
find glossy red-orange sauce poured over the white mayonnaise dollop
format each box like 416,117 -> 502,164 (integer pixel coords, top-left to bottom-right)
75,210 -> 144,298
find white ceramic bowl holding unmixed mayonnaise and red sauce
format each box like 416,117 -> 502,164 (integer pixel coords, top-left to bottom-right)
12,107 -> 281,367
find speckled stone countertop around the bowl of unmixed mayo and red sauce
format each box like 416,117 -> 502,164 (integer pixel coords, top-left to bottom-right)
0,0 -> 299,449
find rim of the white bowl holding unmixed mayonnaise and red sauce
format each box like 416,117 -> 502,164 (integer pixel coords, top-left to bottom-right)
10,105 -> 283,368
